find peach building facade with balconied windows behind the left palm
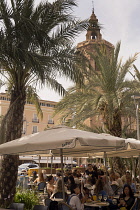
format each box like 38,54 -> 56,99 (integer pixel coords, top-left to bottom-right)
0,93 -> 60,136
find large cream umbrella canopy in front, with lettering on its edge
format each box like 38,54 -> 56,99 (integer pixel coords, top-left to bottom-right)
0,126 -> 126,156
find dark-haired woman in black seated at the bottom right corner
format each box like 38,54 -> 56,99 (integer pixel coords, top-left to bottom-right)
118,184 -> 135,210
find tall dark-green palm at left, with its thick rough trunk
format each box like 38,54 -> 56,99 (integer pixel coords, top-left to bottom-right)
0,0 -> 87,206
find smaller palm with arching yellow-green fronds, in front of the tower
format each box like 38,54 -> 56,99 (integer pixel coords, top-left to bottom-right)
55,42 -> 138,136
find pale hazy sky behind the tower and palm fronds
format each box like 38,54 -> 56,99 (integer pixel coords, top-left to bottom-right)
5,0 -> 140,101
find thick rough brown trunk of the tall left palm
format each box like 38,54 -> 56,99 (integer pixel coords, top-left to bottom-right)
0,90 -> 26,207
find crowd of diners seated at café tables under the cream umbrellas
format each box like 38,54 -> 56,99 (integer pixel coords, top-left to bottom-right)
22,164 -> 136,210
